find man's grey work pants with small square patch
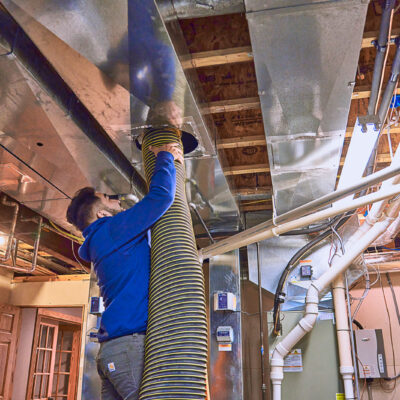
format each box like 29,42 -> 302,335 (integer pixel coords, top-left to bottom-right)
96,333 -> 145,400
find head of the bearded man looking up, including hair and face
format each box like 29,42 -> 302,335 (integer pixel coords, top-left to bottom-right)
67,187 -> 122,232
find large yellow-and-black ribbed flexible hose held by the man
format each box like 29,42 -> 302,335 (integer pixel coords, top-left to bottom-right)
139,128 -> 207,400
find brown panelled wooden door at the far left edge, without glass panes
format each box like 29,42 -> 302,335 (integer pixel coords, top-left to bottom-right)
0,304 -> 20,400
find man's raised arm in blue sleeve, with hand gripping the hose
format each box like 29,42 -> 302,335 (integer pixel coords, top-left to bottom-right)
109,144 -> 183,244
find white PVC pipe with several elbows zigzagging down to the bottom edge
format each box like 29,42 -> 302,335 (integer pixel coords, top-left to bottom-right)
271,200 -> 400,400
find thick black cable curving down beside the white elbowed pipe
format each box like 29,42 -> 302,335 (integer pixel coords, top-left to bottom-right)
273,212 -> 352,335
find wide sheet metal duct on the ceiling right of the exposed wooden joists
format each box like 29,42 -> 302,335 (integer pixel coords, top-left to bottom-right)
245,0 -> 368,215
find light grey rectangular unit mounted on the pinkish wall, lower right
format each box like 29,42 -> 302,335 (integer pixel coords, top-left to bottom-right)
354,329 -> 387,379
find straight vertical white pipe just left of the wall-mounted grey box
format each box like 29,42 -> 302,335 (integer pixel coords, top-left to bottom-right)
332,274 -> 355,400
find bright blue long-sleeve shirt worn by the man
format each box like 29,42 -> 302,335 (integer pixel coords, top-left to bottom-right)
79,151 -> 176,342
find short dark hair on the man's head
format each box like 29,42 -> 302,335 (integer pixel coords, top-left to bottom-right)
67,187 -> 101,232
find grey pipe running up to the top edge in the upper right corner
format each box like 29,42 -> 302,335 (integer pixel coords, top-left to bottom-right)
368,0 -> 396,115
